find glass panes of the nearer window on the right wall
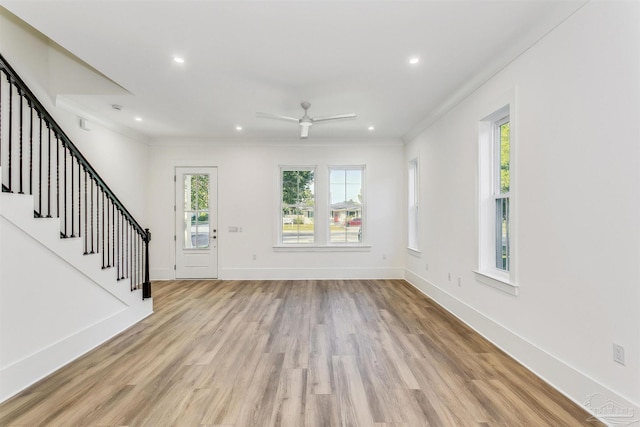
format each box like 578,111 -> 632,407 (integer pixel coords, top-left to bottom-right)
493,116 -> 511,271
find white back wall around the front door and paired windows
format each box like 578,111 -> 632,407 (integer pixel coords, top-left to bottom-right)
147,139 -> 405,279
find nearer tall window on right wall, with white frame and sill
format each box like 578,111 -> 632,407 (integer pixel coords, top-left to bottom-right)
476,104 -> 517,295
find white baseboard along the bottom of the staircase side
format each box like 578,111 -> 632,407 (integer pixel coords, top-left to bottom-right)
0,299 -> 153,402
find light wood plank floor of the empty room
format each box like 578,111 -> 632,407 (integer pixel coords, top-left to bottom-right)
0,280 -> 602,427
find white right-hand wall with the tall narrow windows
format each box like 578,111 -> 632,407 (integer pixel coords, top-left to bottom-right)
405,2 -> 640,418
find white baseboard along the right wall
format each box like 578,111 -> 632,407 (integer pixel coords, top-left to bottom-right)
404,270 -> 640,426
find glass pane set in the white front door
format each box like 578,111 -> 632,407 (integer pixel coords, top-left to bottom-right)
183,174 -> 209,249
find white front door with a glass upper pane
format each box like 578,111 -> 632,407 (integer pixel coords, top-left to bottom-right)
175,167 -> 218,279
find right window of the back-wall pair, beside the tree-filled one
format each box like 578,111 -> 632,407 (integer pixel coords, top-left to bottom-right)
329,166 -> 364,243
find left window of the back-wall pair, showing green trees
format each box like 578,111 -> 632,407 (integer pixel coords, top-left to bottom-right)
280,168 -> 316,244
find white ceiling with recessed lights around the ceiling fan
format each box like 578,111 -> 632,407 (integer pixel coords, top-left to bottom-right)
0,0 -> 585,139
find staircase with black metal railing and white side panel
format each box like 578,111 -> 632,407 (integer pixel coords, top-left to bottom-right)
0,55 -> 152,402
